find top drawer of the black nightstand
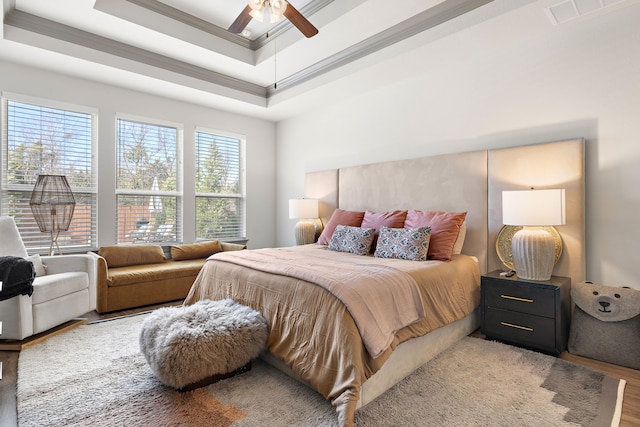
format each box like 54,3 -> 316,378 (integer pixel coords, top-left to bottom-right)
483,280 -> 556,317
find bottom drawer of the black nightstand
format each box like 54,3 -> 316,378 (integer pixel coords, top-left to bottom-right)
484,308 -> 556,350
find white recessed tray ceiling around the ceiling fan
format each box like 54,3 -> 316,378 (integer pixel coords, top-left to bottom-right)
0,0 -> 531,120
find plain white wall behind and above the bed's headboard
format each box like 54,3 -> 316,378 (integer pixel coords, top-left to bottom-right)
276,0 -> 640,289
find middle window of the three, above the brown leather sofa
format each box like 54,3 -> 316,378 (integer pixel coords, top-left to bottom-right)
116,118 -> 181,243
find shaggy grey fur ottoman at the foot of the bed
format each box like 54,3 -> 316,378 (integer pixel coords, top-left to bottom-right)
140,299 -> 268,391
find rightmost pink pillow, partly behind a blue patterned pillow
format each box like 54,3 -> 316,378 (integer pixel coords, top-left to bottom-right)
404,210 -> 467,261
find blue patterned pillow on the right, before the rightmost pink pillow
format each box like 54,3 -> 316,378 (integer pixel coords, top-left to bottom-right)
374,226 -> 431,261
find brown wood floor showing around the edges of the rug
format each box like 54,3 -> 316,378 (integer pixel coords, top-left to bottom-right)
0,308 -> 640,427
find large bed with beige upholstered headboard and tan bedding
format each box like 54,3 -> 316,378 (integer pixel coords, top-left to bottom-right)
185,140 -> 584,426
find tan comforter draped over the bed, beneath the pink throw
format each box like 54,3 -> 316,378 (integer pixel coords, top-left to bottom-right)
185,245 -> 480,426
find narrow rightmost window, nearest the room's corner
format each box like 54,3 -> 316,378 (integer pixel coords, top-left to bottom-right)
196,130 -> 244,239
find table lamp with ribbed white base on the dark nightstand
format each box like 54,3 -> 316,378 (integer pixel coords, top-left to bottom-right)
502,189 -> 565,281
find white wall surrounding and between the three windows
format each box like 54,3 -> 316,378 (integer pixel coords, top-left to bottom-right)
0,58 -> 275,248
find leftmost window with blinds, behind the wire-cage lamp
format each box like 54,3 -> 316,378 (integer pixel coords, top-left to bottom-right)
0,95 -> 97,253
